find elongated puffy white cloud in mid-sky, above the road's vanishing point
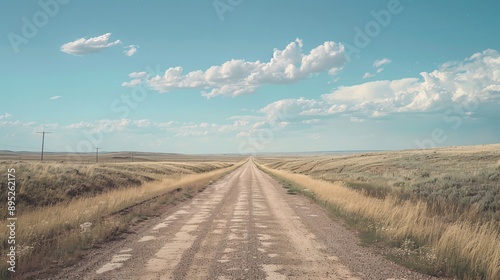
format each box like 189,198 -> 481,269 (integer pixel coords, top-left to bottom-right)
123,39 -> 346,98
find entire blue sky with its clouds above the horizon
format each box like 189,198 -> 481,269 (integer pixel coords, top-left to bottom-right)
0,0 -> 500,153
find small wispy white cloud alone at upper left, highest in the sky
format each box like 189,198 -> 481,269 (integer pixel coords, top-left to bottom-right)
61,33 -> 121,55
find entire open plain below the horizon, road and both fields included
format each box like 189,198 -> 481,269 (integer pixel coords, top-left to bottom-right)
1,145 -> 500,279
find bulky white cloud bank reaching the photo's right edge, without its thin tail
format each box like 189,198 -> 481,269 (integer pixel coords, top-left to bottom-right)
261,50 -> 500,121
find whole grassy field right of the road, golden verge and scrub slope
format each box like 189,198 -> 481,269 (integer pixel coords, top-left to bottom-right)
257,145 -> 500,279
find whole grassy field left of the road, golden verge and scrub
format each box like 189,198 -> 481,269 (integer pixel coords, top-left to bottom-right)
0,157 -> 246,279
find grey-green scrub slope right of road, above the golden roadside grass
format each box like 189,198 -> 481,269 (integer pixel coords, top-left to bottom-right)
259,145 -> 500,222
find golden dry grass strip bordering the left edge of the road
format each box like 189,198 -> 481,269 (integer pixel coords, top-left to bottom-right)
0,160 -> 240,277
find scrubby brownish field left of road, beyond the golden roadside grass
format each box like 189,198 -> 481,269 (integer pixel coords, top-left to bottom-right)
0,161 -> 232,213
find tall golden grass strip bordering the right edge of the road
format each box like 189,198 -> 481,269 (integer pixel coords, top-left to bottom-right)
260,166 -> 500,279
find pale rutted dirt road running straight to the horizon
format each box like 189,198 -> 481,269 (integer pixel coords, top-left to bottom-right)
57,161 -> 438,280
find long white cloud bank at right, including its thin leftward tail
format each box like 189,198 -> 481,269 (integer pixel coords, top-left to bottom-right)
175,50 -> 500,139
